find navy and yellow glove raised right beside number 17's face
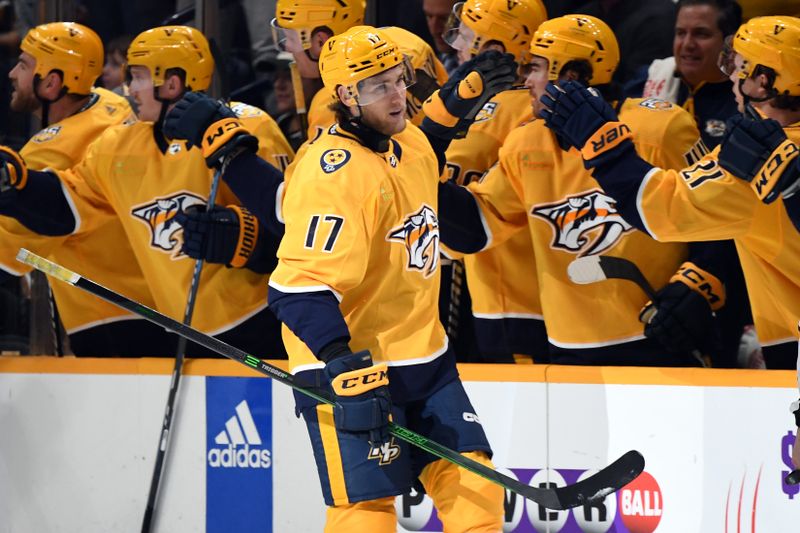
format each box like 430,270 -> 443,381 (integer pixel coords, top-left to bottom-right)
422,50 -> 517,139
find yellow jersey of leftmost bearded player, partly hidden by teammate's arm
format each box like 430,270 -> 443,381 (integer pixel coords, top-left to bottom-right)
0,89 -> 154,334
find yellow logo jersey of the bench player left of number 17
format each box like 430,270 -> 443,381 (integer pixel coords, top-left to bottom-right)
47,105 -> 292,335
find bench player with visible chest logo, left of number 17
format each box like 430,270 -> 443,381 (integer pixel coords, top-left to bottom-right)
0,26 -> 291,357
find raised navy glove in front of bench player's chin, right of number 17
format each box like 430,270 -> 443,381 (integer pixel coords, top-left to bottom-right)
541,81 -> 633,168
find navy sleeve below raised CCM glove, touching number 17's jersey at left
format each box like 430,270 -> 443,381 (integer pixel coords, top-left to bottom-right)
222,152 -> 283,235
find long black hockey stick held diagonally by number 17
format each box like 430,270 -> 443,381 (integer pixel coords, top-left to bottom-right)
17,248 -> 644,510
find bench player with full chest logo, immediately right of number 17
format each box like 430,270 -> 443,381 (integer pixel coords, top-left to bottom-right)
439,15 -> 732,365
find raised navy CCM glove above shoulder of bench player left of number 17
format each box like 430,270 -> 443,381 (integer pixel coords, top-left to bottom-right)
164,91 -> 258,168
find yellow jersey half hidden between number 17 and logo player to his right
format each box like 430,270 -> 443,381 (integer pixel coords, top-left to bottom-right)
447,89 -> 542,328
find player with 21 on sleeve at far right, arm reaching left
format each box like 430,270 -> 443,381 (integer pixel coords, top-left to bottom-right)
545,17 -> 800,368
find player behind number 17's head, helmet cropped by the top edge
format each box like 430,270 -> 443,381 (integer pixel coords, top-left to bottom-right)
271,0 -> 364,139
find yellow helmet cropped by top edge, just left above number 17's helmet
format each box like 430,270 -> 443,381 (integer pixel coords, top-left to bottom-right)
273,0 -> 364,50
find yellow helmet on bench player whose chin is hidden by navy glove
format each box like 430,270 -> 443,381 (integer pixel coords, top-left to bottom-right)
531,15 -> 619,85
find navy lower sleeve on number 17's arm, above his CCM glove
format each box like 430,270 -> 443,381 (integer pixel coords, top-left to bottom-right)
267,285 -> 350,357
